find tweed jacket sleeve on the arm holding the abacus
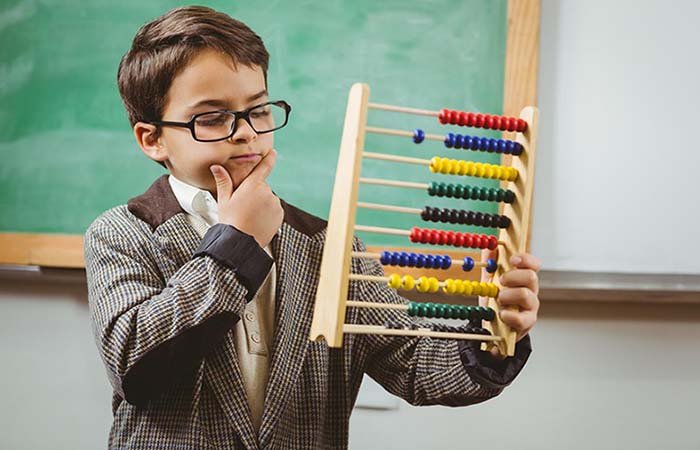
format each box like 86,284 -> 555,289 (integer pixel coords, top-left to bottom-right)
353,240 -> 531,406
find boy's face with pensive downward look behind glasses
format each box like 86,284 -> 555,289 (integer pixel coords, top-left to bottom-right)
134,49 -> 274,197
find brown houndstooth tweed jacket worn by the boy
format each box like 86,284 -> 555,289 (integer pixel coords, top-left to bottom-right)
85,176 -> 530,450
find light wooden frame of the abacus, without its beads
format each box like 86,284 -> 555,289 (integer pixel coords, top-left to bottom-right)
309,83 -> 538,356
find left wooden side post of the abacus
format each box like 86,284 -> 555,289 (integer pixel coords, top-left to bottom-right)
309,83 -> 369,347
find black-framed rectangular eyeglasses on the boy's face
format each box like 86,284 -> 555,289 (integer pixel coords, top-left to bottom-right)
148,100 -> 292,142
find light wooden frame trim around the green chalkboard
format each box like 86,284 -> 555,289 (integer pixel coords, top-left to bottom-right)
0,0 -> 540,268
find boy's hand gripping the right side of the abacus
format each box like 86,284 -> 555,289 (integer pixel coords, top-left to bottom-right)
479,250 -> 542,341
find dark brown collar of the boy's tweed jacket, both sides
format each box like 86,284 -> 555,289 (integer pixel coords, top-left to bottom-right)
127,175 -> 327,237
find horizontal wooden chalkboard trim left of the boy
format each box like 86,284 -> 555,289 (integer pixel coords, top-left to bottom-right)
0,233 -> 85,269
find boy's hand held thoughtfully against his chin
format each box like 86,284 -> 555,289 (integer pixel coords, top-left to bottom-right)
209,149 -> 284,247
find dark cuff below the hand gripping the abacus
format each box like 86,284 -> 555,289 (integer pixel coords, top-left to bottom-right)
458,335 -> 532,389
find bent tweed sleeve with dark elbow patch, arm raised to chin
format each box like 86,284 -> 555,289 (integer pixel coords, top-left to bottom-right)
85,216 -> 272,405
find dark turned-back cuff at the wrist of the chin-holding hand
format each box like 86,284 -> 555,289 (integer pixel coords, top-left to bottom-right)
194,223 -> 273,301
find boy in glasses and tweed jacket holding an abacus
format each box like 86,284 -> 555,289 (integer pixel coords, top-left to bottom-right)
85,7 -> 539,449
